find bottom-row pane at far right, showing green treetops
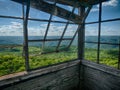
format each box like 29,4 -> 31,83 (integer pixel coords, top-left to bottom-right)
100,44 -> 119,68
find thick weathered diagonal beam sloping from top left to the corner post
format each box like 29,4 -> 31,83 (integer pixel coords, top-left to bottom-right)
12,0 -> 82,23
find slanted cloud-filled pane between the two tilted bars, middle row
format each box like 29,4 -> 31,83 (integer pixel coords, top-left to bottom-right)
47,23 -> 65,39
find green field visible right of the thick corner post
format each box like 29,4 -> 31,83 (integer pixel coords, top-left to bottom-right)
85,48 -> 119,68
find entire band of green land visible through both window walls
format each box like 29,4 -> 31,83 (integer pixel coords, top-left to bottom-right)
0,46 -> 118,76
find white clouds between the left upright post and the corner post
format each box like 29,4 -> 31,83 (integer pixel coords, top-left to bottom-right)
28,24 -> 77,36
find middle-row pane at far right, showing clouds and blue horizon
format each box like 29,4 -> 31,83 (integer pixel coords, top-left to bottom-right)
101,21 -> 120,44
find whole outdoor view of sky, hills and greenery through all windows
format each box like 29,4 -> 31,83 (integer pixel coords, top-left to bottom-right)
0,0 -> 120,76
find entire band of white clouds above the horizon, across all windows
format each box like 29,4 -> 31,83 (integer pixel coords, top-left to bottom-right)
0,22 -> 120,36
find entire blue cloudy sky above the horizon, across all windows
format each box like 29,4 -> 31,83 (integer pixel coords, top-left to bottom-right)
0,0 -> 120,36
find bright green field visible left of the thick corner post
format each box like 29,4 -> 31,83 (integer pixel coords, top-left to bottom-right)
0,47 -> 77,76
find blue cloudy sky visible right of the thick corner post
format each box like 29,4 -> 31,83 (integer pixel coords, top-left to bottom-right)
86,0 -> 120,36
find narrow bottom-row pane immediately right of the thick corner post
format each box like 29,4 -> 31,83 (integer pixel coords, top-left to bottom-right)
85,43 -> 97,62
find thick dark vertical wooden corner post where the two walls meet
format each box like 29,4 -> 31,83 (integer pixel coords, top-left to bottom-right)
78,6 -> 85,90
